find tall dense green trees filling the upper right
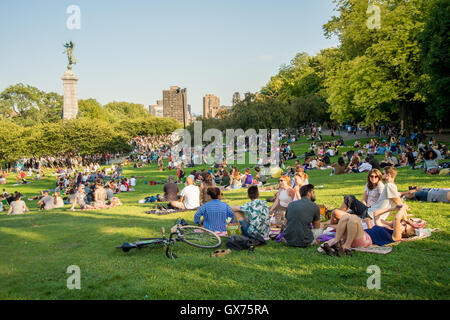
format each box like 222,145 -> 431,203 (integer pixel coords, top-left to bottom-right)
192,0 -> 450,130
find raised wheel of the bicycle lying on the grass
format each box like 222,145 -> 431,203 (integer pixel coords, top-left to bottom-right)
179,226 -> 222,249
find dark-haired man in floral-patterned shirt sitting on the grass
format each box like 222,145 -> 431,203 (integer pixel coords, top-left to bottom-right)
231,186 -> 270,239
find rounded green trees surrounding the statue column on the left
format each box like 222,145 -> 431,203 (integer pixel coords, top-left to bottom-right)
0,84 -> 181,163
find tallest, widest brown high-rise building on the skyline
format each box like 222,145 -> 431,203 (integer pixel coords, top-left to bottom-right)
163,86 -> 190,125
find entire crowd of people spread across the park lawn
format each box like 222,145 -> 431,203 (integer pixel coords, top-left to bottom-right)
0,126 -> 450,255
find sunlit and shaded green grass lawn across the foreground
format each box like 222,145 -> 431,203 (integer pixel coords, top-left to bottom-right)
0,141 -> 450,299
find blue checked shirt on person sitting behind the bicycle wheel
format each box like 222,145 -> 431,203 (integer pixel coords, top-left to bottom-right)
194,199 -> 234,231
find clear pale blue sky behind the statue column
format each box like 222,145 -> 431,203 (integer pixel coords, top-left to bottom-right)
0,0 -> 337,114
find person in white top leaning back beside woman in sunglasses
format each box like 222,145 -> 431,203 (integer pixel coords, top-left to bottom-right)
330,167 -> 403,225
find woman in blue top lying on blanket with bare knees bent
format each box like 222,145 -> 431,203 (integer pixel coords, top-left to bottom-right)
321,204 -> 415,256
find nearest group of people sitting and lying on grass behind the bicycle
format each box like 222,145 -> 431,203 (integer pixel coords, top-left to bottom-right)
164,166 -> 450,255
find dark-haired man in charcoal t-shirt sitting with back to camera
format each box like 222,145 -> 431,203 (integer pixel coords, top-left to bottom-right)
280,184 -> 323,247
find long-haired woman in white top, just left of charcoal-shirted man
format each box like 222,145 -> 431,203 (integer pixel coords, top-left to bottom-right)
269,176 -> 298,228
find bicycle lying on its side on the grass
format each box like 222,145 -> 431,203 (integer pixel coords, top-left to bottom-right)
116,219 -> 222,259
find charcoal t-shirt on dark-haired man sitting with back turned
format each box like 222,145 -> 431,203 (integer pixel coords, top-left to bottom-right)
284,198 -> 320,247
